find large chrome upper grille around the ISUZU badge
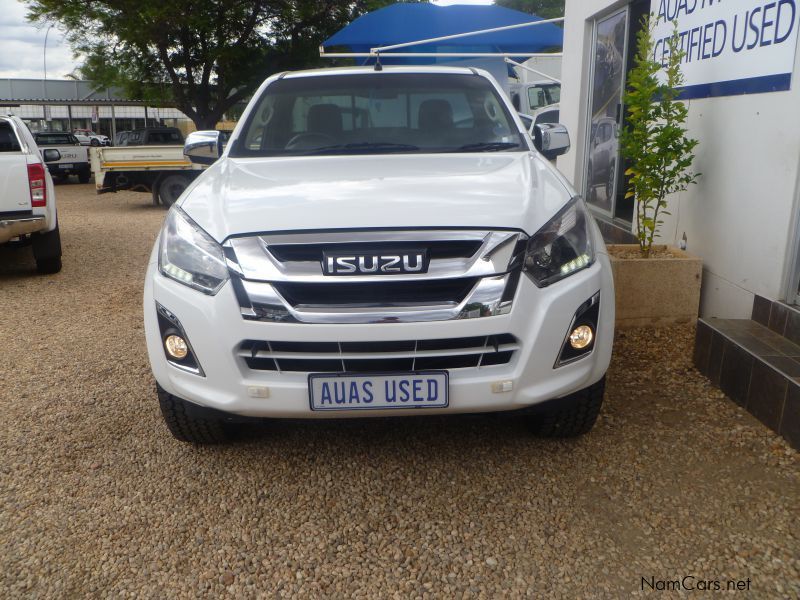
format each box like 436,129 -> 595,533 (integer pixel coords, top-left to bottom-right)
225,229 -> 527,323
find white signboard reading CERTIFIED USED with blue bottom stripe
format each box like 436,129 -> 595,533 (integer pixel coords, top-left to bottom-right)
650,0 -> 800,98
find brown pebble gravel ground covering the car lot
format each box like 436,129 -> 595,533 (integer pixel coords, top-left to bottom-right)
0,184 -> 800,598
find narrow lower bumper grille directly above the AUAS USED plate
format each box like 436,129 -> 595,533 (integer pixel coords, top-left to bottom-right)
238,333 -> 519,373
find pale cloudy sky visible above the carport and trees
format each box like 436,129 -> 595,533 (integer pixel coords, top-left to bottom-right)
0,0 -> 492,79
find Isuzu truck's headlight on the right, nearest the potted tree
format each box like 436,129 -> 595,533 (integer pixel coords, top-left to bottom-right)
523,197 -> 594,287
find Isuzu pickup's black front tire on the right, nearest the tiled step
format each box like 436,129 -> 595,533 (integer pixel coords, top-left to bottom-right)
529,377 -> 606,438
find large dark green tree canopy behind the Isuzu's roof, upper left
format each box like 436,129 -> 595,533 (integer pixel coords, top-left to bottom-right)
24,0 -> 412,129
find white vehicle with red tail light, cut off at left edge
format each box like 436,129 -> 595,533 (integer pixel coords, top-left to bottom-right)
0,116 -> 61,273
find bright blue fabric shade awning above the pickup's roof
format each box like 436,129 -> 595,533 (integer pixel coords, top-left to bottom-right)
323,3 -> 564,56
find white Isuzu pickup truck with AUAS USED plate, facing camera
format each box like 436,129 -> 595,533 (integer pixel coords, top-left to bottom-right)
144,67 -> 614,443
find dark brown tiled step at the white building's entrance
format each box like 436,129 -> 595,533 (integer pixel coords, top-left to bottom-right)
694,318 -> 800,449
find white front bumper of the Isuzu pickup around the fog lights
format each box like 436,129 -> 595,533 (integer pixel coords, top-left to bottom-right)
144,254 -> 614,418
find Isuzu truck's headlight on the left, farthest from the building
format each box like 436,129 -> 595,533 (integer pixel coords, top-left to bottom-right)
158,206 -> 228,296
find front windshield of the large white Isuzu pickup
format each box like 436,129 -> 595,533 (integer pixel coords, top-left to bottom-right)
230,72 -> 528,156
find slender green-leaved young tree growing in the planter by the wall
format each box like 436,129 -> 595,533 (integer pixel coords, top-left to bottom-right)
620,16 -> 699,258
